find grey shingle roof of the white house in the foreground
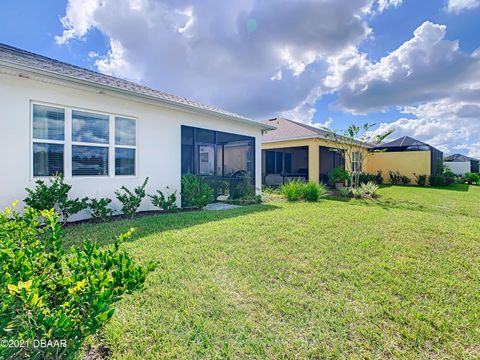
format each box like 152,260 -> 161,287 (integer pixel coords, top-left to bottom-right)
0,43 -> 271,130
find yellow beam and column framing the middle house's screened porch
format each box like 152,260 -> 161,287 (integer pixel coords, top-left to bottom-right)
262,138 -> 367,183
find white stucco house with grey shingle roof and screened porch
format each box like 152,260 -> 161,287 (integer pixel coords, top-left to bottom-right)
0,44 -> 273,215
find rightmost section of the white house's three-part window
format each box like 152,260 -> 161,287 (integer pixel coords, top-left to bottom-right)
115,117 -> 137,175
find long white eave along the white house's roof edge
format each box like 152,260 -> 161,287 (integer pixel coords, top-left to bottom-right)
0,60 -> 276,131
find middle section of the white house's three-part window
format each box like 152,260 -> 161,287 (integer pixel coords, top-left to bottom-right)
72,110 -> 110,176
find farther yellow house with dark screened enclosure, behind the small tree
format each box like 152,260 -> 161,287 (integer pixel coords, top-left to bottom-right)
365,136 -> 443,181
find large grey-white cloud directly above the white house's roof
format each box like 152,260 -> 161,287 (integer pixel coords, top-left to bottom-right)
56,0 -> 394,119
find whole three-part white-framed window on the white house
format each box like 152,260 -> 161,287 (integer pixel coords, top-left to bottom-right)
32,103 -> 137,177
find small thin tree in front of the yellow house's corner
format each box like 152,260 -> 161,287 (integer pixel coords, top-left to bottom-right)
326,123 -> 393,188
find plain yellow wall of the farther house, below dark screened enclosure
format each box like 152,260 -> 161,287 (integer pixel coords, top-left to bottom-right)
365,151 -> 431,182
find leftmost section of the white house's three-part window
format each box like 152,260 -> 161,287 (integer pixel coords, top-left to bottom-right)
32,105 -> 65,176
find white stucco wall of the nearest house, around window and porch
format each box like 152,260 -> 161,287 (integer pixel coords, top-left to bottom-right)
0,72 -> 261,219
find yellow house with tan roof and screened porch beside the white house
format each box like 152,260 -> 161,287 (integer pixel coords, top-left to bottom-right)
262,118 -> 368,186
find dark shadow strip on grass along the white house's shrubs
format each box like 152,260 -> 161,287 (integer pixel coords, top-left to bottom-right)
64,204 -> 278,249
